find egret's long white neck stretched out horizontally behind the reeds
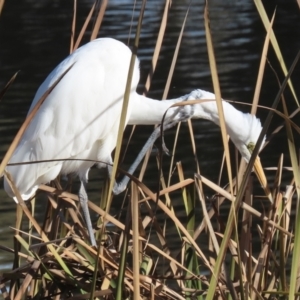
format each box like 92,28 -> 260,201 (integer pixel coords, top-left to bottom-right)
128,90 -> 261,149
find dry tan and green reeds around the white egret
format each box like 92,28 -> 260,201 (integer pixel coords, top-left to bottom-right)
0,0 -> 300,299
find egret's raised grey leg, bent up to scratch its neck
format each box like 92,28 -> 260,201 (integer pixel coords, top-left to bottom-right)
112,118 -> 186,195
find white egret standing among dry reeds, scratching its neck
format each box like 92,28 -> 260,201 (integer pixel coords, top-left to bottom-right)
4,38 -> 261,245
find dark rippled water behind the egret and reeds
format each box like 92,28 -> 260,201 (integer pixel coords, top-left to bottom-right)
0,0 -> 300,270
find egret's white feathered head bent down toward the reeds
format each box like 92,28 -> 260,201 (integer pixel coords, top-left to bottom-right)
227,113 -> 265,162
